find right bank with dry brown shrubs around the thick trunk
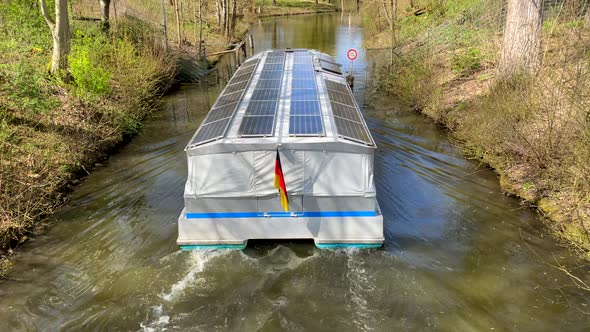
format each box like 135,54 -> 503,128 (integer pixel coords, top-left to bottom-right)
368,0 -> 590,258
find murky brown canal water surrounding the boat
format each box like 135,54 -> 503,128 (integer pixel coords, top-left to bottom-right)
0,15 -> 590,331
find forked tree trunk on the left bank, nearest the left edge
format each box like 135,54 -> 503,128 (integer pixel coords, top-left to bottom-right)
39,0 -> 71,74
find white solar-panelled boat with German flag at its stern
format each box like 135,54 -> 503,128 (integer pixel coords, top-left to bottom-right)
177,49 -> 384,250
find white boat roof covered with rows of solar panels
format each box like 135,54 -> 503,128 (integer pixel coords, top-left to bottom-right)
186,49 -> 375,151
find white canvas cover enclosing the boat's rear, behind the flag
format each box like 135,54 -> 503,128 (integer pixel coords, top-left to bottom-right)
185,150 -> 375,197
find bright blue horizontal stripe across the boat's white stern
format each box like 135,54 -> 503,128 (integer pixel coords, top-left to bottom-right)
186,211 -> 377,219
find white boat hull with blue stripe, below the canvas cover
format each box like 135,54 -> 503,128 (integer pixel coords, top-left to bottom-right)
177,205 -> 384,250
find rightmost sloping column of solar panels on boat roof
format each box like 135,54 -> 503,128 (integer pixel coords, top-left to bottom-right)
325,80 -> 373,145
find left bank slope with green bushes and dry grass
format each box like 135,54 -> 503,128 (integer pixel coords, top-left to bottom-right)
0,0 -> 174,274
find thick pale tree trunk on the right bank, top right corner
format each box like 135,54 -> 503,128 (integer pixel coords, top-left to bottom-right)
498,0 -> 543,79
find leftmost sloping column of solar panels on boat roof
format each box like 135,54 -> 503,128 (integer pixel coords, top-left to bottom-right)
190,59 -> 259,145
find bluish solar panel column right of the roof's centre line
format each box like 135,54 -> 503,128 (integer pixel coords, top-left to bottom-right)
289,51 -> 324,136
